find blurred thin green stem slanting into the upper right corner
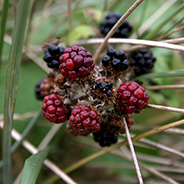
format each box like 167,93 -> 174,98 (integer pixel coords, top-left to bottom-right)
145,3 -> 184,40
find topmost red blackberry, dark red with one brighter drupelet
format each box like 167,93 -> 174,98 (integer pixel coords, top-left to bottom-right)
59,46 -> 95,80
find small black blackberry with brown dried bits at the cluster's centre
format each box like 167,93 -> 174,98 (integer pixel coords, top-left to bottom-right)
90,78 -> 115,102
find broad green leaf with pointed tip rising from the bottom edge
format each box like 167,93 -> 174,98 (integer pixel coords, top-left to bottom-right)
20,148 -> 49,184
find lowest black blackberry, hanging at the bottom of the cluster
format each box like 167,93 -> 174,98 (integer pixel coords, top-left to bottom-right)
93,122 -> 118,147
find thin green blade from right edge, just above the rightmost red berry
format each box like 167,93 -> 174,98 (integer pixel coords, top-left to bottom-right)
133,69 -> 184,80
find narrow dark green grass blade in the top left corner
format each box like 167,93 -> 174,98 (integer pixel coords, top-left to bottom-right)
0,0 -> 9,65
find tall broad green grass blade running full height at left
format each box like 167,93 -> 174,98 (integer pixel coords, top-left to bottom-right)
3,0 -> 32,184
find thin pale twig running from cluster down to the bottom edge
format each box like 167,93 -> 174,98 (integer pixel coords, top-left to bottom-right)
123,118 -> 143,184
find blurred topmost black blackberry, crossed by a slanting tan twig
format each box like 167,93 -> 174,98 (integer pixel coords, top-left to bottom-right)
100,12 -> 132,38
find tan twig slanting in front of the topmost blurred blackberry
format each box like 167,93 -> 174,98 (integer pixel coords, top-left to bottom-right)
94,0 -> 143,61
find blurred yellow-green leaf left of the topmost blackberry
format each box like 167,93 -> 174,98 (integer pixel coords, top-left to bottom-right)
68,25 -> 94,42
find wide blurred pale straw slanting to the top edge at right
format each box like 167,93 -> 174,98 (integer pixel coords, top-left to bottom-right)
138,0 -> 177,34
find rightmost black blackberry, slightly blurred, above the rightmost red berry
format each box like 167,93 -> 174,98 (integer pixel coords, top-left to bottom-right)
129,49 -> 156,76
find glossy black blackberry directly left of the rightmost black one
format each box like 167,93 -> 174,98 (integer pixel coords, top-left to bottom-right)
102,48 -> 128,76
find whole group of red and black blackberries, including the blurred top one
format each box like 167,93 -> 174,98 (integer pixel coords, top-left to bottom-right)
35,13 -> 156,147
